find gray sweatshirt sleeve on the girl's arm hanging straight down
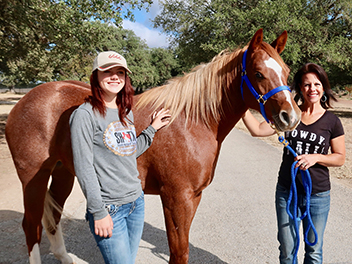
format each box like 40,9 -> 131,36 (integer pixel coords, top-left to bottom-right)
70,108 -> 107,220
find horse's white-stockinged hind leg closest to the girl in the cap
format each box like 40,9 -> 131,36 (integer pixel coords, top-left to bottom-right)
43,163 -> 74,264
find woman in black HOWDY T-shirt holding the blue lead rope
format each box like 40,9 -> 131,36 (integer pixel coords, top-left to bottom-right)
242,63 -> 346,264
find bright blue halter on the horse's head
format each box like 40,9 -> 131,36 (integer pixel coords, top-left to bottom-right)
241,50 -> 291,124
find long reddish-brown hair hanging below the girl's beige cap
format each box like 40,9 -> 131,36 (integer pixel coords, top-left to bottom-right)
85,70 -> 134,126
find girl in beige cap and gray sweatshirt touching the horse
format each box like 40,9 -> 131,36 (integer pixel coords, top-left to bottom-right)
70,51 -> 170,264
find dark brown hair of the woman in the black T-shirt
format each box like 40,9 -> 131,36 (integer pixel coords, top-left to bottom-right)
291,63 -> 337,109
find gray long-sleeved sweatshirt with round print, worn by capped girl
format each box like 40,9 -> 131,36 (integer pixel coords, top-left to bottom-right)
70,103 -> 156,220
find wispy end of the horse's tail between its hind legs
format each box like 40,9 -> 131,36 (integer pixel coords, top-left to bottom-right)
42,190 -> 63,233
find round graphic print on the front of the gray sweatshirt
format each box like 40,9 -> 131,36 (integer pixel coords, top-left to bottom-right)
104,121 -> 137,156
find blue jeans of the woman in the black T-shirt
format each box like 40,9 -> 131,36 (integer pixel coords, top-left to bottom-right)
275,184 -> 330,264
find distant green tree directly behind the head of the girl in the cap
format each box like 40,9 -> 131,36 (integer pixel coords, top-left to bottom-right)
55,21 -> 178,93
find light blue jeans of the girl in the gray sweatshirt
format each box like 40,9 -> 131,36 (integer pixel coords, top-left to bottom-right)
87,193 -> 144,264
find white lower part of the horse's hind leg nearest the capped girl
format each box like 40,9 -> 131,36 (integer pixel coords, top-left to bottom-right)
43,221 -> 73,264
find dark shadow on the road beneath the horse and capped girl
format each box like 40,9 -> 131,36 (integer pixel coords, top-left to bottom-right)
0,210 -> 226,264
